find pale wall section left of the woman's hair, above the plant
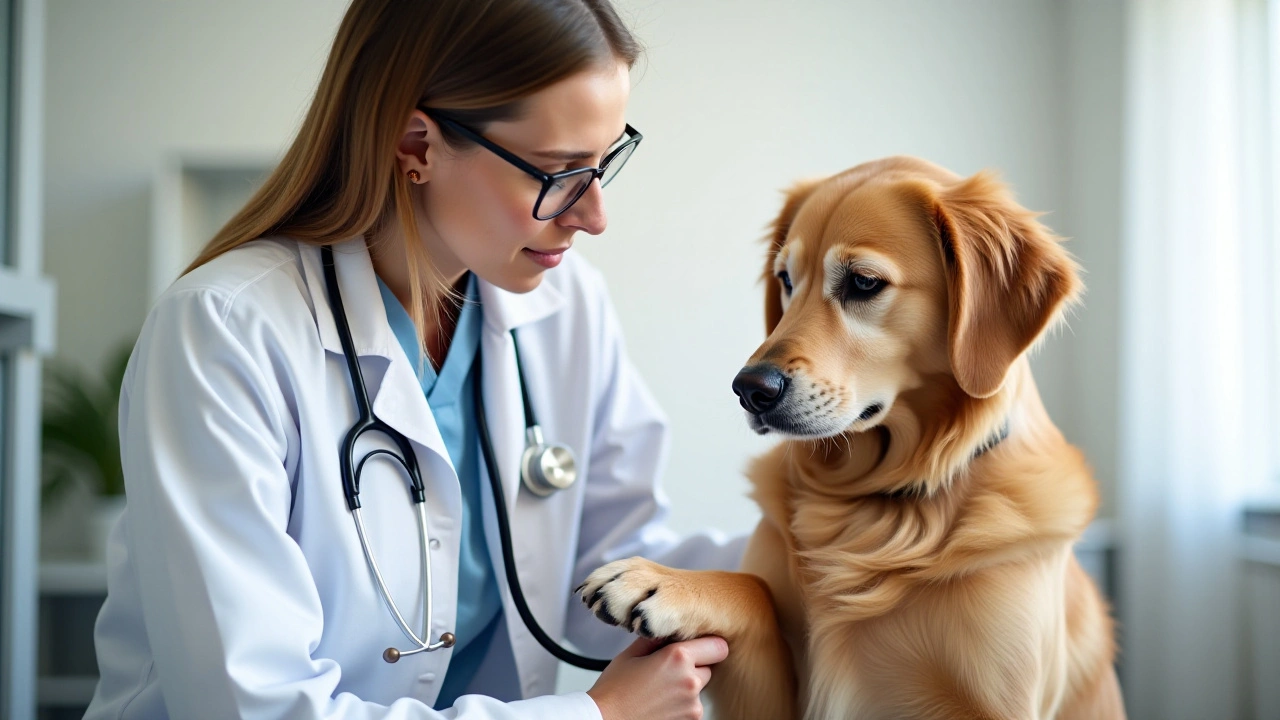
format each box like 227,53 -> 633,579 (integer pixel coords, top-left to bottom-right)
45,0 -> 346,376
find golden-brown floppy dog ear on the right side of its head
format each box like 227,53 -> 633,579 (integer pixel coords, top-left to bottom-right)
933,172 -> 1082,397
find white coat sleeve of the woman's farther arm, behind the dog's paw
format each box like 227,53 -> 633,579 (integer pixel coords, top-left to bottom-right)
564,271 -> 748,656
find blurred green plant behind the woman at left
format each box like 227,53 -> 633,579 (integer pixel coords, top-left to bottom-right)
40,342 -> 133,503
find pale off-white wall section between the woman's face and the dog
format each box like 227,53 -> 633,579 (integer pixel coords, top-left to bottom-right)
579,0 -> 1088,529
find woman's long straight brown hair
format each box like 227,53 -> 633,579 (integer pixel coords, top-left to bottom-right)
184,0 -> 640,345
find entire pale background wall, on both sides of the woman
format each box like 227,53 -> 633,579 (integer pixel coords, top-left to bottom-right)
45,0 -> 1121,540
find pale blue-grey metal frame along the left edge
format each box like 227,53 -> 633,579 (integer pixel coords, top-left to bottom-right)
0,0 -> 54,720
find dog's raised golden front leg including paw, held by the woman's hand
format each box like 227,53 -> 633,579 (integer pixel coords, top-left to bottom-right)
579,557 -> 796,720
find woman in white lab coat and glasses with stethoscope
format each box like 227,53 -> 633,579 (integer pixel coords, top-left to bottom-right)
87,0 -> 742,720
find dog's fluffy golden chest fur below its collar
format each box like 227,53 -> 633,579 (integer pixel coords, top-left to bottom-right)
753,435 -> 1091,720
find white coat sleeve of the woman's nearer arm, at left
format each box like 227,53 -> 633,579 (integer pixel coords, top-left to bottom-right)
112,290 -> 600,720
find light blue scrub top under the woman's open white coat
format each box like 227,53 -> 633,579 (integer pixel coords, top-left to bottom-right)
378,275 -> 502,710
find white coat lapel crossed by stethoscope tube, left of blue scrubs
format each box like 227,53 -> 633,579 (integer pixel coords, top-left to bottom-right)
301,237 -> 455,468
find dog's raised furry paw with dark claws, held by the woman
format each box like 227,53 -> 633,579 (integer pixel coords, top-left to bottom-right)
573,557 -> 705,641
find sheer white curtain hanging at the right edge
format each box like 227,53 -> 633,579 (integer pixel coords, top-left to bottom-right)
1119,0 -> 1280,720
